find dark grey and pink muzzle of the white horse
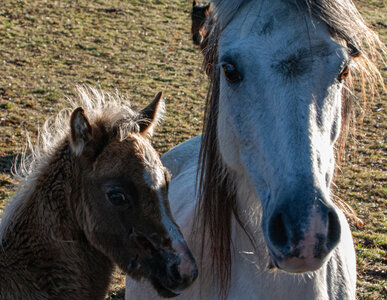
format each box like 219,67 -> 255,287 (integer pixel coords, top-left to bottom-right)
267,198 -> 341,273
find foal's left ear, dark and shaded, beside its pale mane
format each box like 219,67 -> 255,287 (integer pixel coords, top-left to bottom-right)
70,107 -> 92,155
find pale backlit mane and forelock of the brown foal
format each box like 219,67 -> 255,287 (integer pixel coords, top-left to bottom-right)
0,86 -> 146,244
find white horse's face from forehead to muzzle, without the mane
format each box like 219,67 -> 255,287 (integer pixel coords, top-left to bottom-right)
217,1 -> 348,272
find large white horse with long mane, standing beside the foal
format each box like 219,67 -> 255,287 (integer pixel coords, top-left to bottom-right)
126,0 -> 383,300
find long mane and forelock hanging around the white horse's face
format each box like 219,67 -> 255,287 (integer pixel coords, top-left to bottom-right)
199,0 -> 386,298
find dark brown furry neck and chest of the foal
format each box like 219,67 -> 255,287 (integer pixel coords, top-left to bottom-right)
0,142 -> 112,299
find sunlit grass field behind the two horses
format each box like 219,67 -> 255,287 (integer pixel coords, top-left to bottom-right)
0,0 -> 387,299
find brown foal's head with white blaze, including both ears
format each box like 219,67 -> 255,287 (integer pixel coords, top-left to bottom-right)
70,93 -> 197,297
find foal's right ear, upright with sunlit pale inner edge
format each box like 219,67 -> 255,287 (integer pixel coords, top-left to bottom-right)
138,92 -> 164,135
